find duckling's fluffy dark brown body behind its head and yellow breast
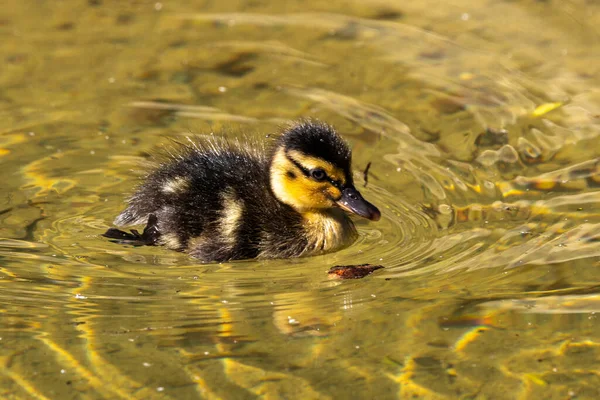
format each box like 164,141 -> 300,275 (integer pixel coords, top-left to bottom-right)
115,139 -> 307,261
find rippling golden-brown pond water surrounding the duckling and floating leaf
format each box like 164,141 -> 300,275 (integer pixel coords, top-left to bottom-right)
0,0 -> 600,399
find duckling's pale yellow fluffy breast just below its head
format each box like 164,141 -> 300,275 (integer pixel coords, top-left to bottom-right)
301,208 -> 358,253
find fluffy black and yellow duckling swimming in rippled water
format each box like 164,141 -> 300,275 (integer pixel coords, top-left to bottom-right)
104,121 -> 381,262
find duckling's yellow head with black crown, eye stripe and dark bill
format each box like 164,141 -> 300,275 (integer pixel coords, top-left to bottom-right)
270,121 -> 381,221
